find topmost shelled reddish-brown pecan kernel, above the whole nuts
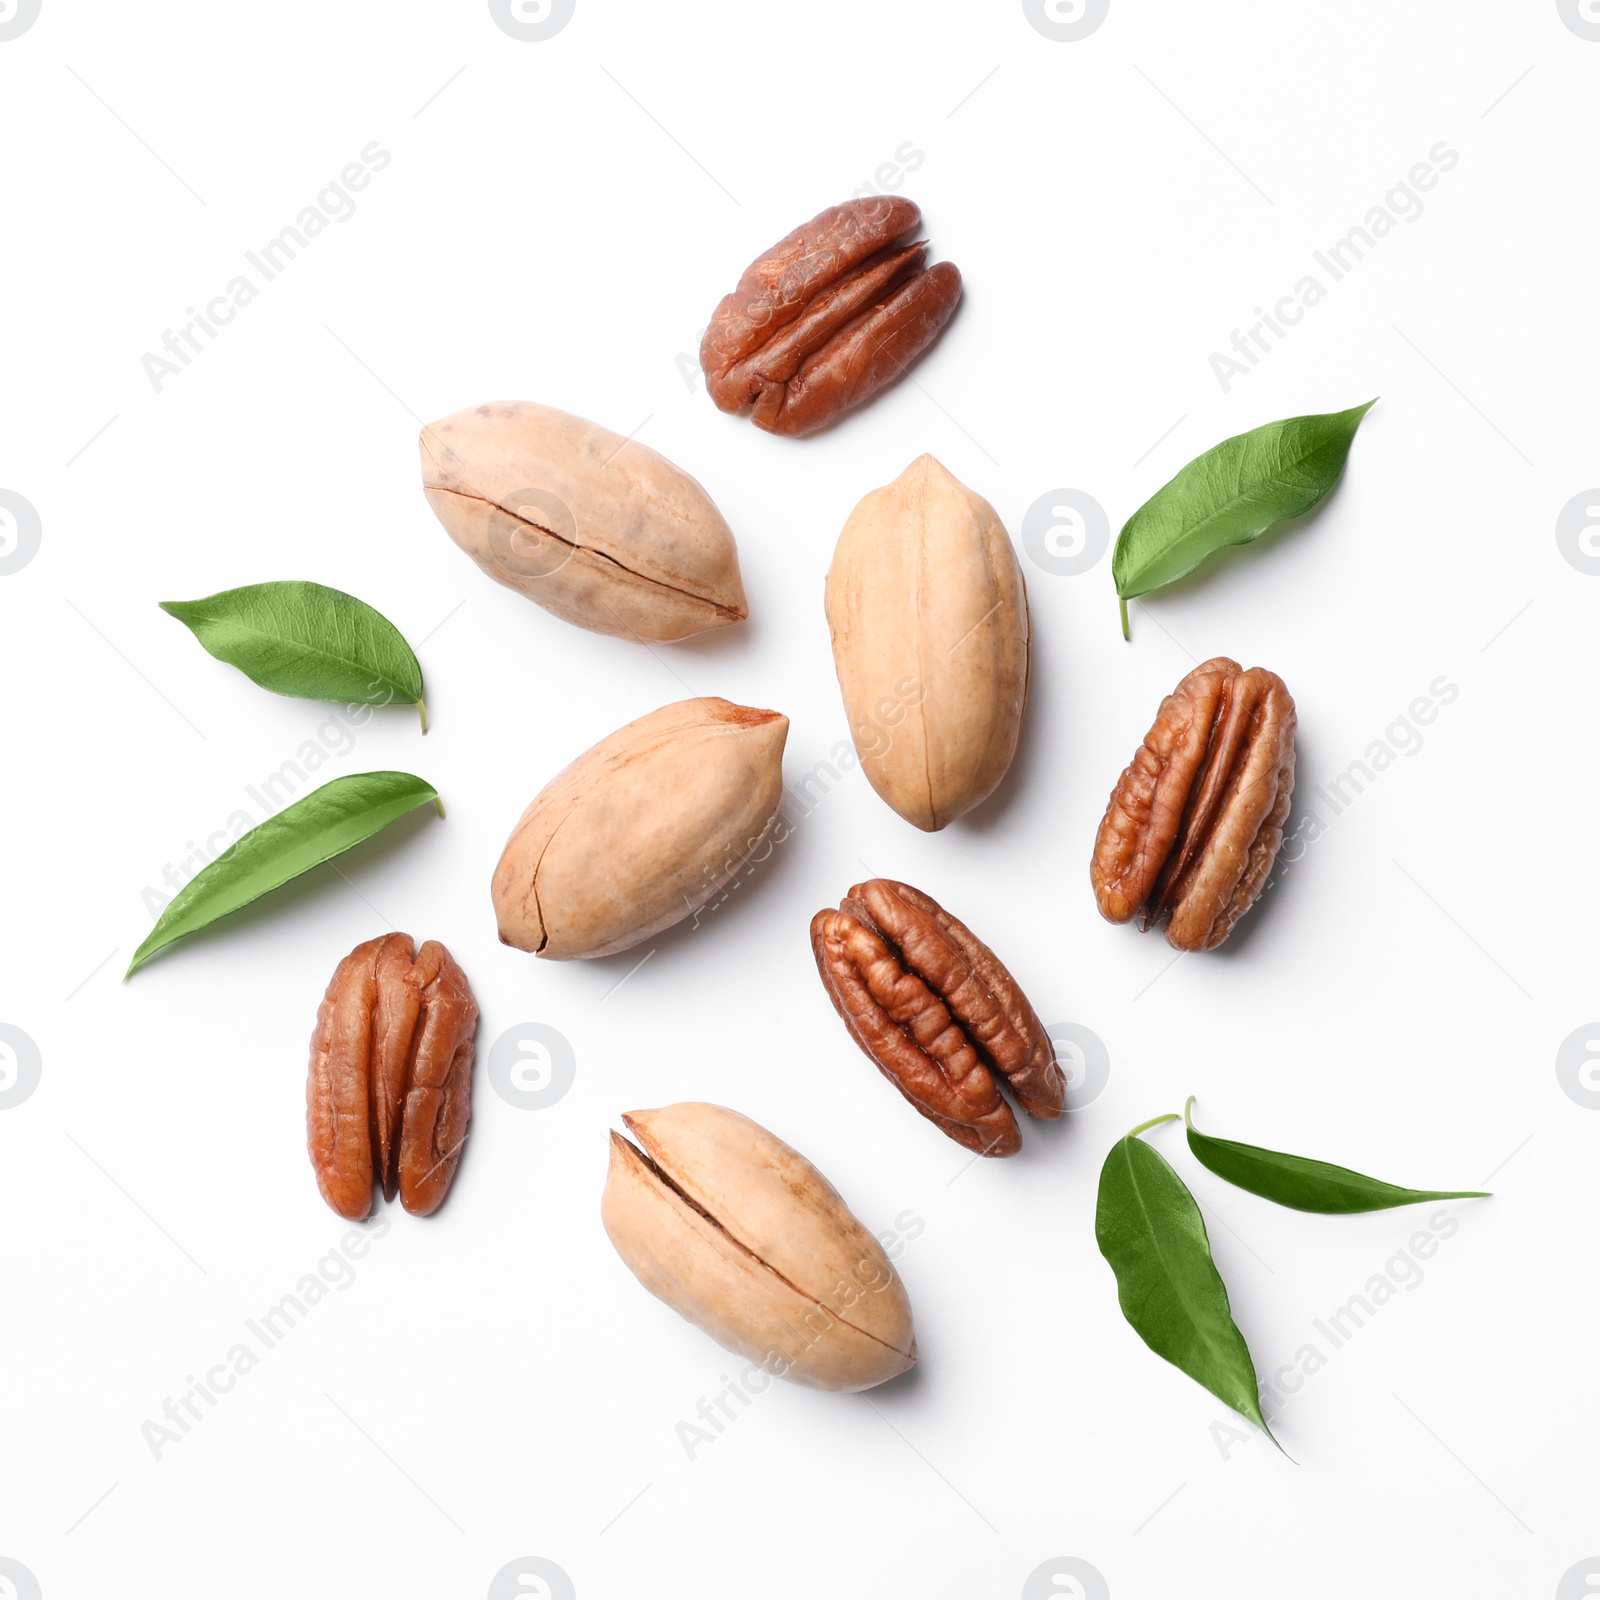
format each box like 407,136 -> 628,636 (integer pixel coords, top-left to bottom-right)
701,195 -> 962,434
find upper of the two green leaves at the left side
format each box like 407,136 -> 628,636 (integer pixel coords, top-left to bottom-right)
162,582 -> 427,733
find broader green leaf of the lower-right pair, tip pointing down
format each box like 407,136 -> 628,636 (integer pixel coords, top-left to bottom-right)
1094,1115 -> 1277,1443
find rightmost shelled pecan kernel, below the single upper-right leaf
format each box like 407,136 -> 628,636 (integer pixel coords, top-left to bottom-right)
1090,656 -> 1294,950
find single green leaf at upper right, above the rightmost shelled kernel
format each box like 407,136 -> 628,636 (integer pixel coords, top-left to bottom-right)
1110,400 -> 1378,638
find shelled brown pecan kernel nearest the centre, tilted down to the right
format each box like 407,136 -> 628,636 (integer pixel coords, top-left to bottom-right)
811,878 -> 1067,1155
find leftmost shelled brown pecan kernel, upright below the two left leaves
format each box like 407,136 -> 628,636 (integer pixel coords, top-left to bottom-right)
306,933 -> 478,1222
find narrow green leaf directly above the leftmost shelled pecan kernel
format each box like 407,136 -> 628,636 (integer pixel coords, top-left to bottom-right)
123,773 -> 445,979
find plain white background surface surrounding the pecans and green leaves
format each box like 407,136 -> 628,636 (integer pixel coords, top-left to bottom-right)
0,0 -> 1600,1600
